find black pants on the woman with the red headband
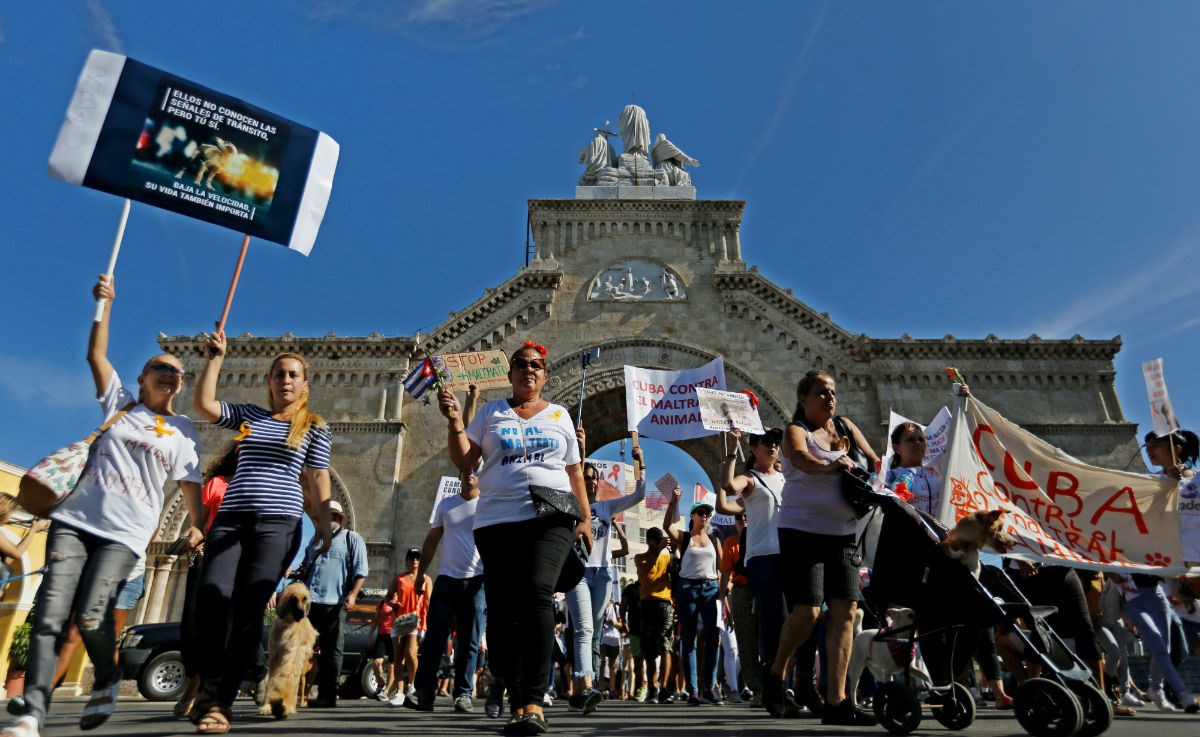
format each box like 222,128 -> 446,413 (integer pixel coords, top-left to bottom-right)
475,515 -> 575,709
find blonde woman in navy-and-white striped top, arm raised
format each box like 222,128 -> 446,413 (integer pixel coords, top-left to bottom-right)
188,331 -> 334,735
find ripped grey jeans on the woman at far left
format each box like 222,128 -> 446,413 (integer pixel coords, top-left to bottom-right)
25,522 -> 138,727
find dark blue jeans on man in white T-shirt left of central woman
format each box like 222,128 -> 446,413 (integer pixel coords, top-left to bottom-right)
414,576 -> 485,699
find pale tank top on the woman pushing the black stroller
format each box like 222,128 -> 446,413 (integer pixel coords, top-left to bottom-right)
779,432 -> 858,535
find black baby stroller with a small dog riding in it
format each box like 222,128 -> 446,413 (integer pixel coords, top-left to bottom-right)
863,497 -> 1112,737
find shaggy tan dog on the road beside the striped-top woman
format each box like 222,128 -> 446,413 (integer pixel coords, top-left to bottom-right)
258,581 -> 317,719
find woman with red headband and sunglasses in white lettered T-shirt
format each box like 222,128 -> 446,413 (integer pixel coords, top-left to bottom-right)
438,341 -> 592,735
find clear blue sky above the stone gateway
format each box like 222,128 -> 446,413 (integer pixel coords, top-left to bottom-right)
0,0 -> 1200,492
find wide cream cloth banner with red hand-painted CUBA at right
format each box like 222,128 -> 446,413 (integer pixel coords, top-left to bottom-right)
938,397 -> 1184,574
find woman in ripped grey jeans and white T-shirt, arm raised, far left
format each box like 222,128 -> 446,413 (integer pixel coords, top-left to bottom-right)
0,276 -> 205,737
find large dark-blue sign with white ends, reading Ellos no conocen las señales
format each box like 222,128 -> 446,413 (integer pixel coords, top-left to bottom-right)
49,50 -> 338,256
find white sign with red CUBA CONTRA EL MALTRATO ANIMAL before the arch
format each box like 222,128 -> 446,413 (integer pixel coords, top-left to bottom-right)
625,356 -> 725,441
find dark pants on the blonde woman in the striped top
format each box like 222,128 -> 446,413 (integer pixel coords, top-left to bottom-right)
196,511 -> 300,705
